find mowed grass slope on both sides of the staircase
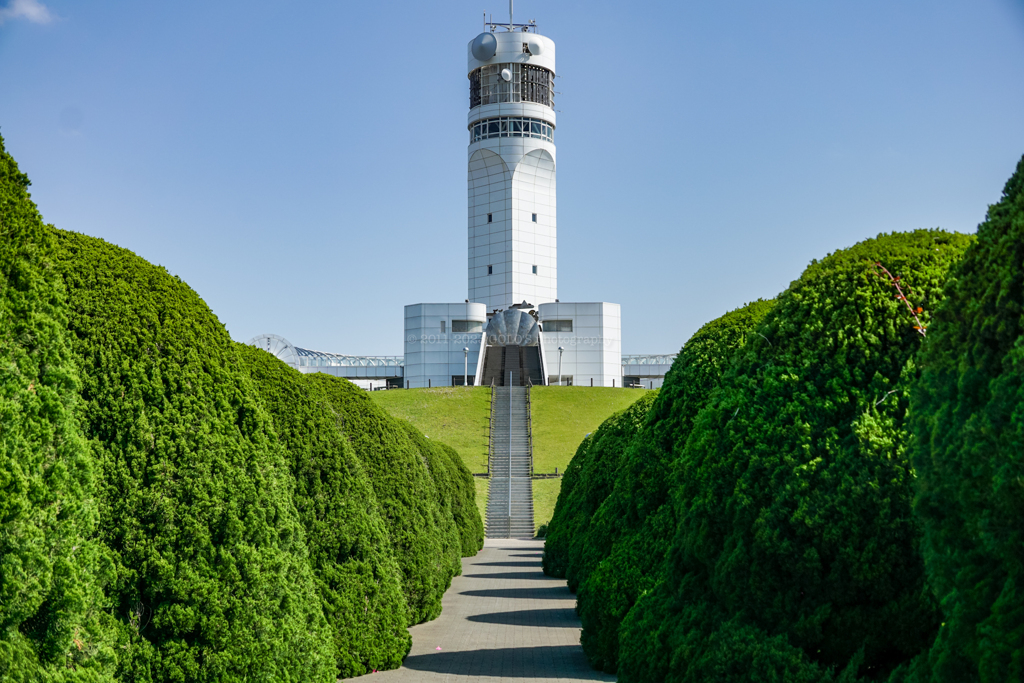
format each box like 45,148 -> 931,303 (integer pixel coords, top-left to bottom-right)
370,386 -> 644,527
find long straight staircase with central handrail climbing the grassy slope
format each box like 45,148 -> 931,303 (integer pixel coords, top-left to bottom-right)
486,382 -> 534,539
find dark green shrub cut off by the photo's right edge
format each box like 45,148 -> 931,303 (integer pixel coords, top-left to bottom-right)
911,159 -> 1024,683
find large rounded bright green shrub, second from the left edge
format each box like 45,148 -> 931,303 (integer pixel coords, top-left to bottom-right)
56,232 -> 336,681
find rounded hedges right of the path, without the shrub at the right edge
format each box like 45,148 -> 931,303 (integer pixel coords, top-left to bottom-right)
551,223 -> 995,682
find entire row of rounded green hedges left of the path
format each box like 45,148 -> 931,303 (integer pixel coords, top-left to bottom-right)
0,135 -> 482,681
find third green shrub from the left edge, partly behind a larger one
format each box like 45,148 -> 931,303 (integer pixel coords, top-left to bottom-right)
238,344 -> 411,678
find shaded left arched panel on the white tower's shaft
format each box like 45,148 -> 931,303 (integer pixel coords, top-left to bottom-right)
469,150 -> 512,308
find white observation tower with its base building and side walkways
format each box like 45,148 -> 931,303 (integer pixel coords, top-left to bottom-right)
250,10 -> 671,393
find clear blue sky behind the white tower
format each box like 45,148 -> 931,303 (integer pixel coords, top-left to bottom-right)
0,0 -> 1024,354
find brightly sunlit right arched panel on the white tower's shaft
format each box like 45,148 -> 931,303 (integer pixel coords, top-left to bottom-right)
512,150 -> 558,304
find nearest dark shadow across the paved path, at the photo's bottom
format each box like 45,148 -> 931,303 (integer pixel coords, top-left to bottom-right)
403,645 -> 607,681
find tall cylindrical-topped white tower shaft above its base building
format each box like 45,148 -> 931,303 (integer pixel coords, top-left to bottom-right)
467,23 -> 558,311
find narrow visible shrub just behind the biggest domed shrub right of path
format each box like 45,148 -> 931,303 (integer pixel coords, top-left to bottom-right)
578,300 -> 773,673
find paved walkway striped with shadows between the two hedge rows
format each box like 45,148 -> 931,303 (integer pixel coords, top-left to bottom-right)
350,539 -> 615,683
